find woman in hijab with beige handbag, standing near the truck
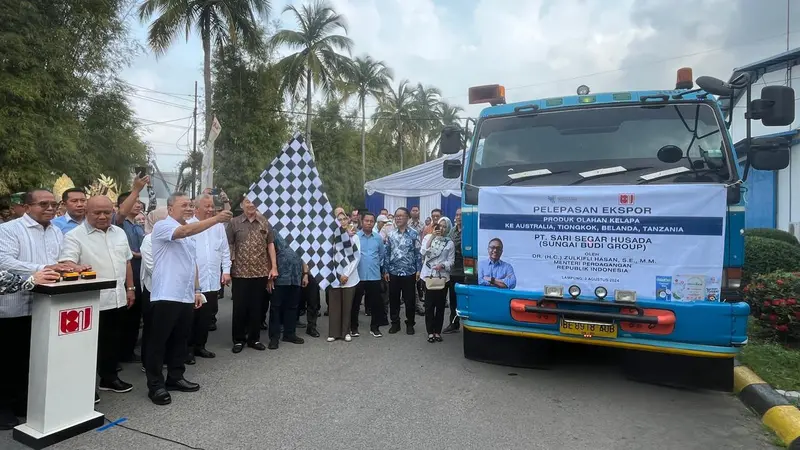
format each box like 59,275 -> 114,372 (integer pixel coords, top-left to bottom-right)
420,217 -> 456,342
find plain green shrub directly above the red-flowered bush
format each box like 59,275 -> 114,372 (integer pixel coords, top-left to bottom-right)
743,236 -> 800,283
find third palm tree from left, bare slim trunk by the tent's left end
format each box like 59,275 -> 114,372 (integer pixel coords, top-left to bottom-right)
342,56 -> 394,183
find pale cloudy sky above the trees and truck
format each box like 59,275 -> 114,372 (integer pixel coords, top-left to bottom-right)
122,0 -> 800,176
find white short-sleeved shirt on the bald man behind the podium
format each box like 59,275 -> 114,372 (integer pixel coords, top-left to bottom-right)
58,221 -> 133,311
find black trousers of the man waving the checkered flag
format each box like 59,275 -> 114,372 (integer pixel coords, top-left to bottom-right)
144,300 -> 194,392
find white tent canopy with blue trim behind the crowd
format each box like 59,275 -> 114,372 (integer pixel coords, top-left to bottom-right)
364,152 -> 461,219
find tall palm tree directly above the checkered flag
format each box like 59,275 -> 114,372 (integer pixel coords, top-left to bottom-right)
270,0 -> 353,144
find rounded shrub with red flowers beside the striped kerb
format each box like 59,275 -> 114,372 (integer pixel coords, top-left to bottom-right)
743,271 -> 800,341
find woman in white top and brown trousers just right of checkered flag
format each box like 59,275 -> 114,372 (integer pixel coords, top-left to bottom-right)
328,208 -> 361,342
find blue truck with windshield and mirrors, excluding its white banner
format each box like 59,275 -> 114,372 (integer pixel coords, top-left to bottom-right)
440,68 -> 794,391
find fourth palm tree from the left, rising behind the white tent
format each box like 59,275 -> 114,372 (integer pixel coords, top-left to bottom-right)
372,80 -> 416,170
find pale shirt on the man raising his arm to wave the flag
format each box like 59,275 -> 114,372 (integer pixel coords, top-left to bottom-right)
150,217 -> 197,303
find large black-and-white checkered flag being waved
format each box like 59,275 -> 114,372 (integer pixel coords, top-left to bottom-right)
247,133 -> 340,289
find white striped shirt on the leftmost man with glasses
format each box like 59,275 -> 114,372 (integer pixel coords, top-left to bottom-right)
0,214 -> 64,318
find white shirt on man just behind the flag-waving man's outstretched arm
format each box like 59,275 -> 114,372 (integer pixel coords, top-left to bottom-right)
186,217 -> 231,292
